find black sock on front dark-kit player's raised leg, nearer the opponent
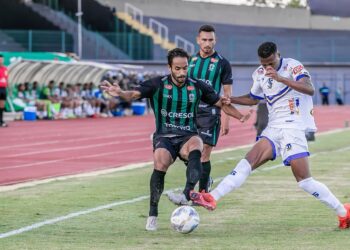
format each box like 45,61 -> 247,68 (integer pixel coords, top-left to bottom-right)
183,150 -> 202,200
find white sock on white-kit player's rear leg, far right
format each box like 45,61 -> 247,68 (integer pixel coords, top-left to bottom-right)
298,177 -> 346,217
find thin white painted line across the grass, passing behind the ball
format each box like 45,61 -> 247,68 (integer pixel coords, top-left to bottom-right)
0,130 -> 350,239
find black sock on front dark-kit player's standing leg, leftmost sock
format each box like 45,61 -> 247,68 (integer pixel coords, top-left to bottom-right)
149,169 -> 166,216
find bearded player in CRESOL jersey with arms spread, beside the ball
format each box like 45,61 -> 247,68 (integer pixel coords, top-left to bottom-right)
101,48 -> 250,231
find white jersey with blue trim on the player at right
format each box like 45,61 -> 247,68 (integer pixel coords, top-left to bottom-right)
250,58 -> 316,131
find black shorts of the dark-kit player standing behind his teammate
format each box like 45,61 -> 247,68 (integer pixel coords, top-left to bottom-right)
197,115 -> 221,147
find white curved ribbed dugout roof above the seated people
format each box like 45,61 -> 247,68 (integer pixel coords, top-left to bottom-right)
9,60 -> 121,85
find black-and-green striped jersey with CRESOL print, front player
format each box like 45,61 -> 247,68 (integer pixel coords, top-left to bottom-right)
135,75 -> 220,135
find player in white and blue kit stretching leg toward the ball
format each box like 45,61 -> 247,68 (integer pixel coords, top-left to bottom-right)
191,42 -> 350,229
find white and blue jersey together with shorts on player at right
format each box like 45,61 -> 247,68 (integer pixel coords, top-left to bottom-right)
250,58 -> 316,166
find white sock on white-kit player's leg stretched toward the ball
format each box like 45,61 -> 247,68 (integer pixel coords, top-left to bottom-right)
210,159 -> 252,200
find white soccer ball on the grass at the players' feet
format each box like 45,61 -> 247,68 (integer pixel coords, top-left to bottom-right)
170,206 -> 199,234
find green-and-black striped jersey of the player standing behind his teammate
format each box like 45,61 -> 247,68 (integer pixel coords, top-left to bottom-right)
188,51 -> 232,116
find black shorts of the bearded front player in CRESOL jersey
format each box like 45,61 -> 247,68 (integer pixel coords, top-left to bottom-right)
153,134 -> 197,161
